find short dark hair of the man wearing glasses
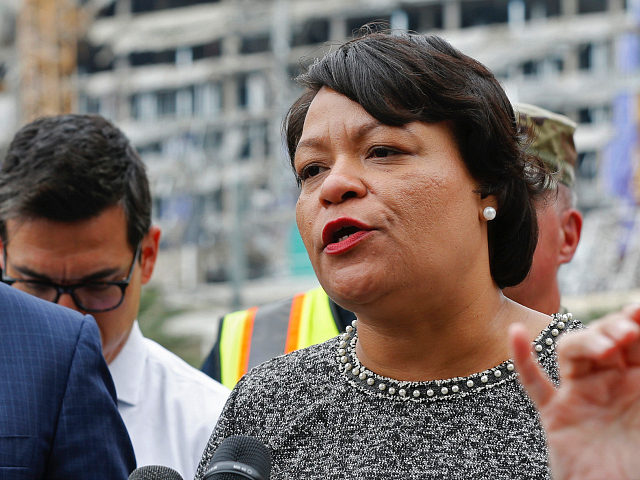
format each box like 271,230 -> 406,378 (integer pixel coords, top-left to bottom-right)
0,115 -> 151,249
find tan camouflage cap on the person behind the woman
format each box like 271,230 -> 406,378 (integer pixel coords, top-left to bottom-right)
513,103 -> 578,187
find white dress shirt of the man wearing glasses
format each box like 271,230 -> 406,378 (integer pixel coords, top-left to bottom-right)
109,321 -> 229,480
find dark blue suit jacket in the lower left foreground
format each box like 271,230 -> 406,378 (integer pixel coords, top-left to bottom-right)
0,284 -> 135,480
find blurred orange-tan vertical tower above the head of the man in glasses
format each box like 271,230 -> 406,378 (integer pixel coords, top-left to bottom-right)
16,0 -> 82,123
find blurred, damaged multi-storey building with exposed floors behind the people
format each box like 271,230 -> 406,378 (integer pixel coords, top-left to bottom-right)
0,0 -> 640,300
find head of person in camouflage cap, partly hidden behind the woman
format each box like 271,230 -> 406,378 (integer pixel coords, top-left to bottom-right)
504,103 -> 582,314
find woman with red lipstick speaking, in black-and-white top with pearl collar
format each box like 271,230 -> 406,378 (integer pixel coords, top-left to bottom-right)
196,33 -> 638,479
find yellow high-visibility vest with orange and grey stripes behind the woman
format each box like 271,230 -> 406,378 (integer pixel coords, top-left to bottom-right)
219,288 -> 339,388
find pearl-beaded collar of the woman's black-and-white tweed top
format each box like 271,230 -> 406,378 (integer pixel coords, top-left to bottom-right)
336,313 -> 573,402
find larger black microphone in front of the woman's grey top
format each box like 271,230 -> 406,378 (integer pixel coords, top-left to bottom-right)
203,435 -> 271,480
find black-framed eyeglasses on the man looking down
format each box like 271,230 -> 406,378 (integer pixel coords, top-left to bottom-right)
2,244 -> 141,313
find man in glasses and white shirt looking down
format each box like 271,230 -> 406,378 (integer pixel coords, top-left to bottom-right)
0,115 -> 228,478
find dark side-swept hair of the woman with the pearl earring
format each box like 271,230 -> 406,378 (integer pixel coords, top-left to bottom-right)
284,32 -> 546,288
